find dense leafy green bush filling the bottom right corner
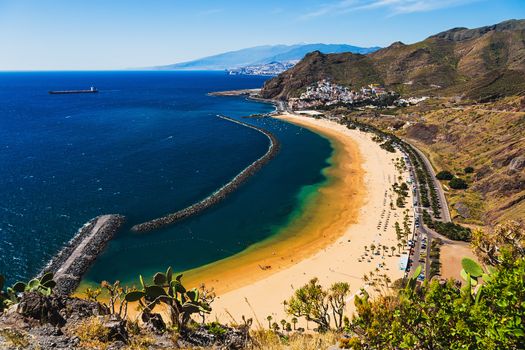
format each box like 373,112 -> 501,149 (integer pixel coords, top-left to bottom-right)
350,253 -> 525,349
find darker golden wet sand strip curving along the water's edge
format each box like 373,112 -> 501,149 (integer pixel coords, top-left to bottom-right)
184,116 -> 365,295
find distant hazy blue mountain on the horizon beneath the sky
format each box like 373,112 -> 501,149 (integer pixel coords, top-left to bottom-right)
154,44 -> 379,70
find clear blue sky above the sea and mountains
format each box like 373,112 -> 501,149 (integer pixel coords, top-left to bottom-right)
0,0 -> 525,71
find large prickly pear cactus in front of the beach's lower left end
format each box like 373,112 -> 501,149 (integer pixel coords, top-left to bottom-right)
125,267 -> 211,329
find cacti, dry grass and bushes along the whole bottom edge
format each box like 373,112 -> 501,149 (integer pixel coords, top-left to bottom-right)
0,222 -> 525,350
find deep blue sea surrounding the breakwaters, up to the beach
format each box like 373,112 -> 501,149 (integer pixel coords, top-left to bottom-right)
0,72 -> 332,282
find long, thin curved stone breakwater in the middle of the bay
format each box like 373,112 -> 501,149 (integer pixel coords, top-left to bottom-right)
131,116 -> 280,232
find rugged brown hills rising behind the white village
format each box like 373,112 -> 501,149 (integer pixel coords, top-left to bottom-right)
262,20 -> 525,100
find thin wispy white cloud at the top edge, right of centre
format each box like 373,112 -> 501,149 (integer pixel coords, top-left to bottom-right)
300,0 -> 480,20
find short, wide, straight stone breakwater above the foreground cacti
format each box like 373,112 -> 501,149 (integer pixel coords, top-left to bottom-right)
40,215 -> 125,295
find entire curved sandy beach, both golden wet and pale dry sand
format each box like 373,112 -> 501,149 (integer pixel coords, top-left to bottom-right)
189,115 -> 413,326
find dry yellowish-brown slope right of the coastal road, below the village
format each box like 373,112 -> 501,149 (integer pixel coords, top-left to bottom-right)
336,96 -> 525,226
